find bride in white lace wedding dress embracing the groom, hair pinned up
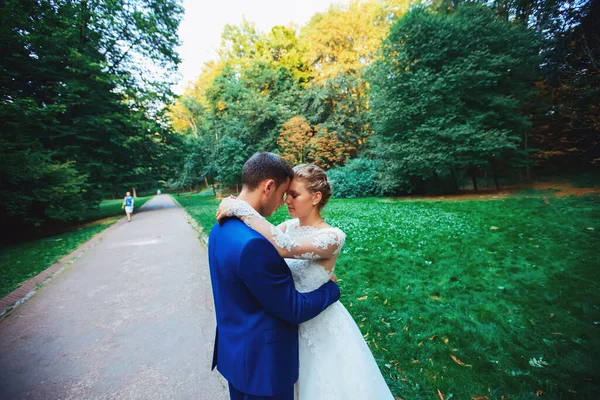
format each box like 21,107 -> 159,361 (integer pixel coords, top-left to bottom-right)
217,164 -> 394,400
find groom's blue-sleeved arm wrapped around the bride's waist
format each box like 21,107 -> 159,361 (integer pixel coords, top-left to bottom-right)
239,238 -> 340,325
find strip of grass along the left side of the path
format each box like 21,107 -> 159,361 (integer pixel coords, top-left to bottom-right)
0,196 -> 153,297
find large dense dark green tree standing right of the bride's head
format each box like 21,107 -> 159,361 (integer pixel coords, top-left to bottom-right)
370,5 -> 536,192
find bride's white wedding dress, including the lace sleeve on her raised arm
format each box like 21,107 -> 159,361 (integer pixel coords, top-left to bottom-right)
223,199 -> 394,400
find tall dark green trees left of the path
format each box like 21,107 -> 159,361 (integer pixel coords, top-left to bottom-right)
0,0 -> 182,234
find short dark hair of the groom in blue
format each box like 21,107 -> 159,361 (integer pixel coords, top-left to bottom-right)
242,152 -> 294,190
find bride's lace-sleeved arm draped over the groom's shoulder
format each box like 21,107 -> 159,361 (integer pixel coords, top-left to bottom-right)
217,198 -> 346,259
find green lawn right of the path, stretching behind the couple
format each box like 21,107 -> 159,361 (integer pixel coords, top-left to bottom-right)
180,192 -> 600,400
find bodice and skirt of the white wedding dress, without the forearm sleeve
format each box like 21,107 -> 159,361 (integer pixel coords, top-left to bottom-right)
285,219 -> 394,400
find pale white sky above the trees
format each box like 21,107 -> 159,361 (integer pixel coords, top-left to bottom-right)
173,0 -> 349,94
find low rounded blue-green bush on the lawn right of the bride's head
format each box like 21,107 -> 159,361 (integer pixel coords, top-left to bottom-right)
327,158 -> 382,198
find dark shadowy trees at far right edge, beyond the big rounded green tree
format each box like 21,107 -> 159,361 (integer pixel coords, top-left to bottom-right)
532,1 -> 600,172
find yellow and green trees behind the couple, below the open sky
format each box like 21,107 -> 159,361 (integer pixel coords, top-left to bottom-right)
170,0 -> 408,185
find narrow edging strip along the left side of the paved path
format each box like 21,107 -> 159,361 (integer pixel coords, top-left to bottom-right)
0,199 -> 154,322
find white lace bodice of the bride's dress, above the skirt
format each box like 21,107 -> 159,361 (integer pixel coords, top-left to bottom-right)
285,219 -> 346,293
